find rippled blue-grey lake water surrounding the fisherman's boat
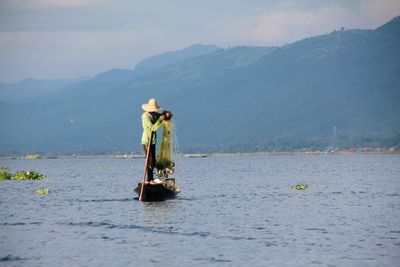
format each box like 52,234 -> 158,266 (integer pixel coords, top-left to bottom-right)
0,155 -> 400,267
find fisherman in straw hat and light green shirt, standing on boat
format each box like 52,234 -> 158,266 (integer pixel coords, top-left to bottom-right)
142,98 -> 172,184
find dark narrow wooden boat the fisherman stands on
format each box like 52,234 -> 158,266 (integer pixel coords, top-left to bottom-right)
134,178 -> 180,201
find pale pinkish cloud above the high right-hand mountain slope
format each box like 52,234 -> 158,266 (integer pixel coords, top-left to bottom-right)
247,0 -> 400,45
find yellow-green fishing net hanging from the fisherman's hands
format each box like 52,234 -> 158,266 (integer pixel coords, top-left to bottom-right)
156,120 -> 175,178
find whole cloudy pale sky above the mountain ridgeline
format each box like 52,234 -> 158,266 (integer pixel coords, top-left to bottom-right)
0,0 -> 400,82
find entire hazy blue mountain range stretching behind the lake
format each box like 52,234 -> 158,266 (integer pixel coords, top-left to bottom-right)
0,18 -> 400,154
